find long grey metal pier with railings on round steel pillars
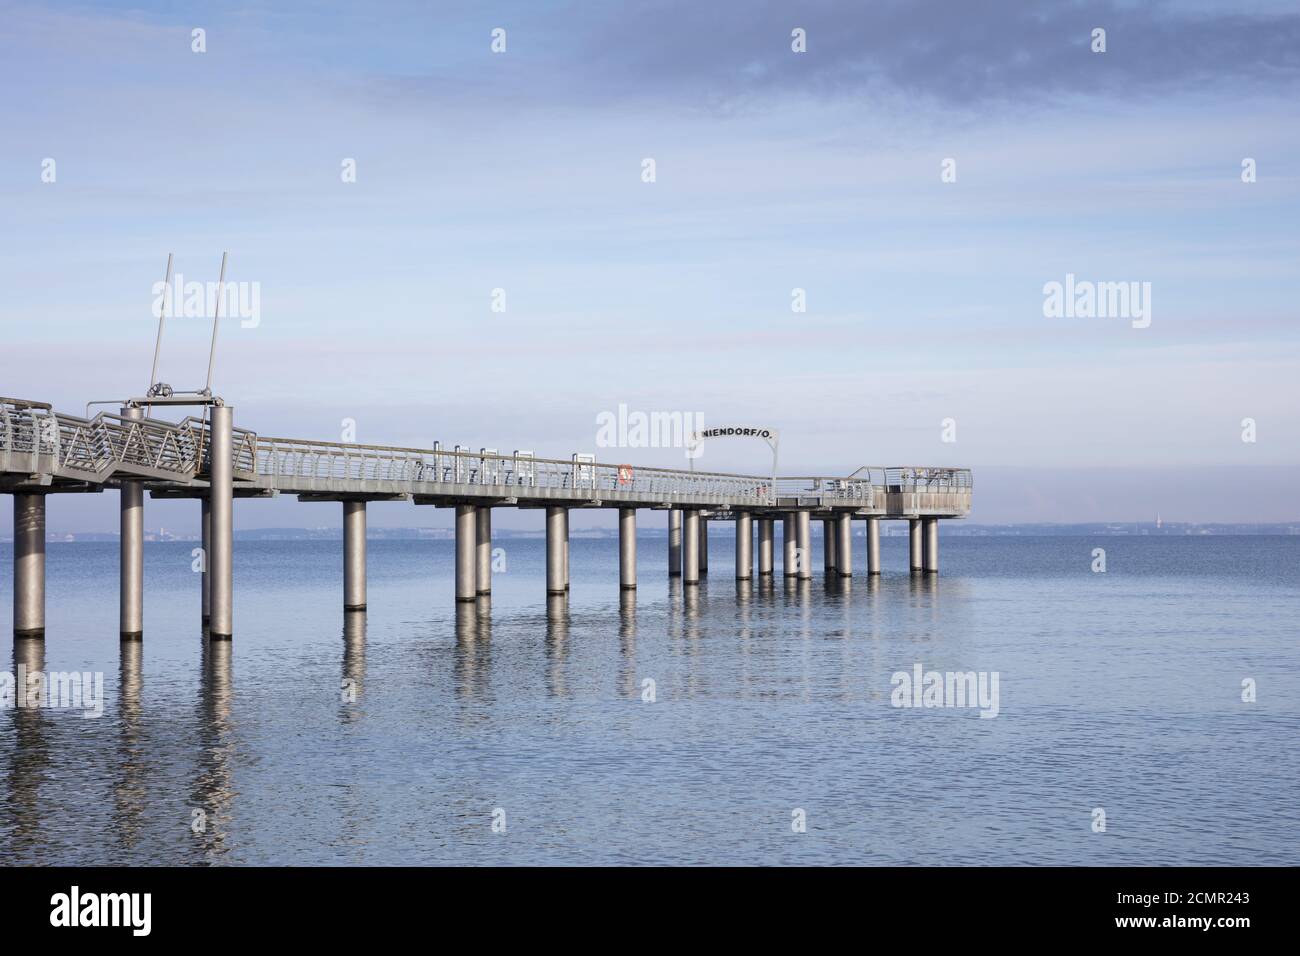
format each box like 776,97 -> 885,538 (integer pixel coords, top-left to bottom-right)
0,398 -> 972,641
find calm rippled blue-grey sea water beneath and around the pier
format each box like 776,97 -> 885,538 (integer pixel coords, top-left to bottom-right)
0,535 -> 1300,865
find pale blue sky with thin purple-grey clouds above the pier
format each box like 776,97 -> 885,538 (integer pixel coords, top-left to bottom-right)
0,0 -> 1300,528
